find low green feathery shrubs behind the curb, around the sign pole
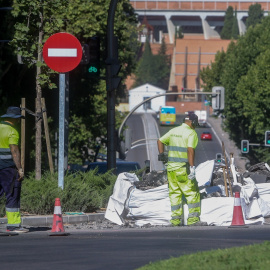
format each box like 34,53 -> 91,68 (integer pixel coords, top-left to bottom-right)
0,171 -> 116,216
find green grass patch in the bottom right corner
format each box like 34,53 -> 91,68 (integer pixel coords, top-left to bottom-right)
137,241 -> 270,270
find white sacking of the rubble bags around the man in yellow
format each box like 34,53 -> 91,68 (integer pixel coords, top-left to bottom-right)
105,161 -> 270,226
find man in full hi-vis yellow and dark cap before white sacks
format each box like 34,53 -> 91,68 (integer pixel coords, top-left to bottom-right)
157,113 -> 202,226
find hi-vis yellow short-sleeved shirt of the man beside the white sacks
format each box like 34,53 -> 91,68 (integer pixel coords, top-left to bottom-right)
159,123 -> 198,171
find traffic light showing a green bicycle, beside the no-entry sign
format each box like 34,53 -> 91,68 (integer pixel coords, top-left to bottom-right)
87,37 -> 100,77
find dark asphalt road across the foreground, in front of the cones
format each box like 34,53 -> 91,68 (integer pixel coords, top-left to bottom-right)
0,226 -> 270,270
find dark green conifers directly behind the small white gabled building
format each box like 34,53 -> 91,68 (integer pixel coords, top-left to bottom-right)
133,39 -> 170,89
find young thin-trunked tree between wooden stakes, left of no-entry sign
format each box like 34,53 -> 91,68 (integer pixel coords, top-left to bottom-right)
11,0 -> 66,179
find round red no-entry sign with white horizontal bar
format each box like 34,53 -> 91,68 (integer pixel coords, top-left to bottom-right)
43,33 -> 82,73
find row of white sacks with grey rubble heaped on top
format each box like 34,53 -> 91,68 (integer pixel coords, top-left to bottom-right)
105,157 -> 270,226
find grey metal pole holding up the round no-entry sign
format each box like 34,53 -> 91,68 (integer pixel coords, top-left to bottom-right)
58,73 -> 66,189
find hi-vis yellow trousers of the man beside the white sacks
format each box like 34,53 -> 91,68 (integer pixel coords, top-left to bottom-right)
167,167 -> 201,225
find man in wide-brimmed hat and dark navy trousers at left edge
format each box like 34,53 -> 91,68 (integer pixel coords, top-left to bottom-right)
0,107 -> 29,233
